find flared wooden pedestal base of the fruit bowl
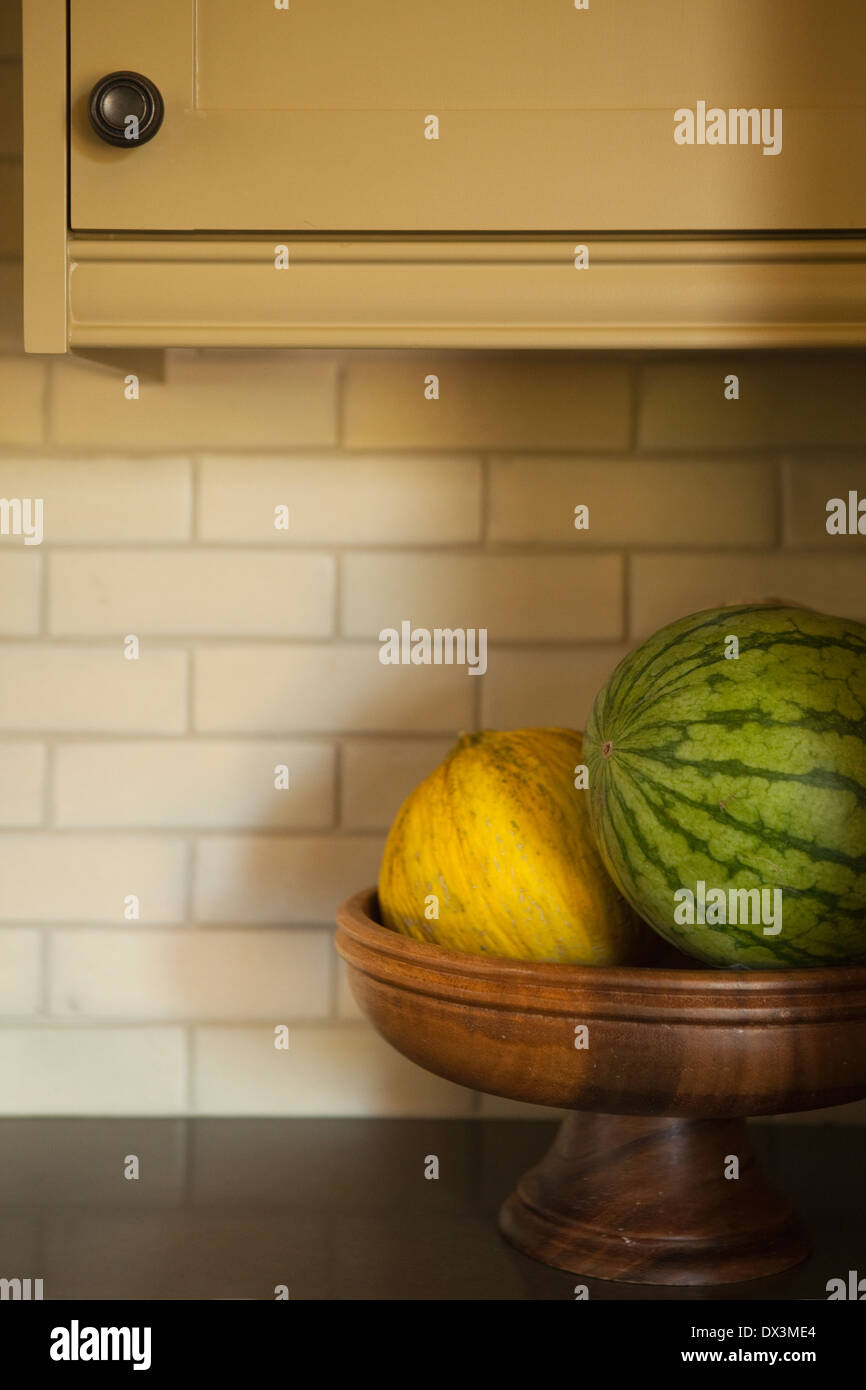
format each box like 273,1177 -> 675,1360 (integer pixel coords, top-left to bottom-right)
499,1113 -> 809,1284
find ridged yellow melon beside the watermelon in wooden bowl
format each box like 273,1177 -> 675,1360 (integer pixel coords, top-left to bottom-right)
379,728 -> 649,965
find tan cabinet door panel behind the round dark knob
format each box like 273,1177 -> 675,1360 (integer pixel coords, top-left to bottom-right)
70,0 -> 866,232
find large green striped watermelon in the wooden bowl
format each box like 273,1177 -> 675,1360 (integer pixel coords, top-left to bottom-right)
584,605 -> 866,967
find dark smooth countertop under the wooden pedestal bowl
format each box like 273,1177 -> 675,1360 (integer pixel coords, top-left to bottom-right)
0,1119 -> 866,1300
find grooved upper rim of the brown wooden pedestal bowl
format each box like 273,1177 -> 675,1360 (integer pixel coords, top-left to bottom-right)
336,885 -> 866,1008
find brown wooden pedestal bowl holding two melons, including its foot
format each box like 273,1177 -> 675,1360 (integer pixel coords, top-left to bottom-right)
336,888 -> 866,1284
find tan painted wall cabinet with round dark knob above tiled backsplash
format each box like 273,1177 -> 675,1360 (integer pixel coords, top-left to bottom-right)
24,0 -> 866,350
